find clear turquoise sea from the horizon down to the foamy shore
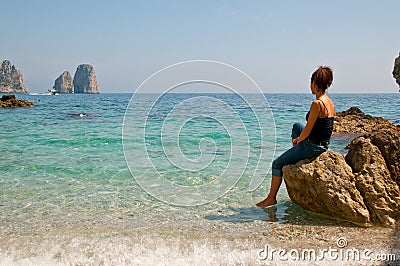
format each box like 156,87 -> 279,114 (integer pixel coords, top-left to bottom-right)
0,91 -> 400,265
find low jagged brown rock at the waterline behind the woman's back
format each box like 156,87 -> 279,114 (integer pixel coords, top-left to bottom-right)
333,107 -> 400,133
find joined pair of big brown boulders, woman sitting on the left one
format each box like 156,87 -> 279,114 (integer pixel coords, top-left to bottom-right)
283,130 -> 400,225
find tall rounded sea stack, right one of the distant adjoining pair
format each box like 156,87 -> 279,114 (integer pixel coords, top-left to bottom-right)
74,64 -> 99,93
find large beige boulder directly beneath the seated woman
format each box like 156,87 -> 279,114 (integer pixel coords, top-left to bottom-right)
283,151 -> 370,224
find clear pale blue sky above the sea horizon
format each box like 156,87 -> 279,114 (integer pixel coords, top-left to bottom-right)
0,0 -> 400,93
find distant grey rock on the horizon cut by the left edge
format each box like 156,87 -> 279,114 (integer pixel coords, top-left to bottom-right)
0,60 -> 29,93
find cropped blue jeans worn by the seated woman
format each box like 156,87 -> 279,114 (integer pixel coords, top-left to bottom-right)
272,123 -> 327,176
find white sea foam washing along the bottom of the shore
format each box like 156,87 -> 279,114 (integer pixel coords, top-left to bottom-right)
0,236 -> 388,266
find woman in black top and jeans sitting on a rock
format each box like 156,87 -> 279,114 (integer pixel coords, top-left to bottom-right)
256,66 -> 335,208
